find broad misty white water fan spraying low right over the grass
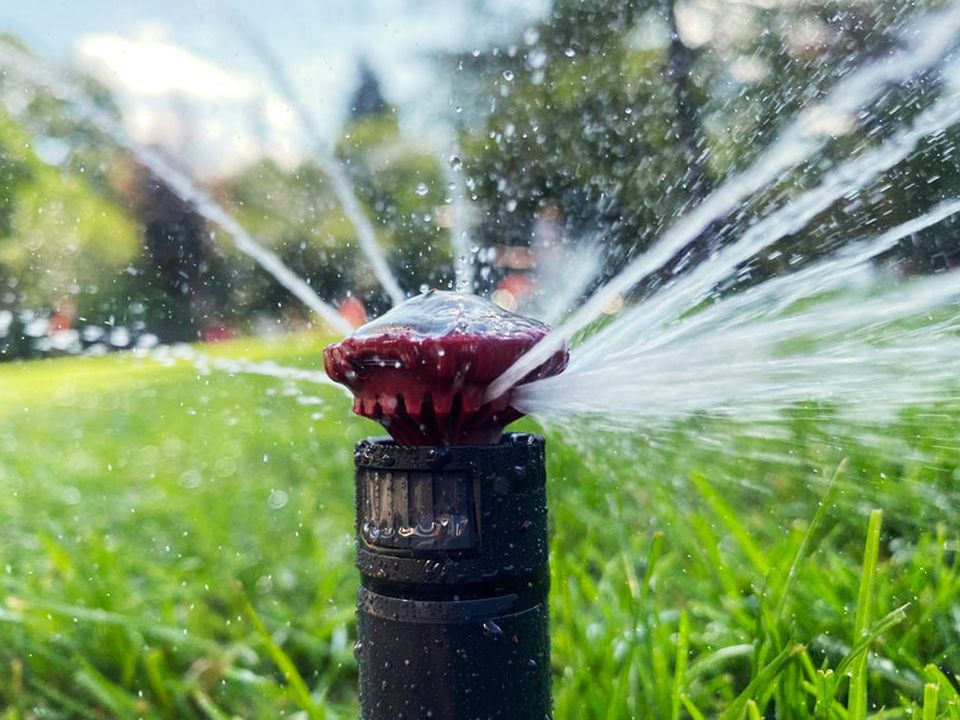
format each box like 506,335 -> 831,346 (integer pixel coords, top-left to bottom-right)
512,275 -> 960,424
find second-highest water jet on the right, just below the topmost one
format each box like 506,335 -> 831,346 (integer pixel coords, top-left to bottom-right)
568,80 -> 960,366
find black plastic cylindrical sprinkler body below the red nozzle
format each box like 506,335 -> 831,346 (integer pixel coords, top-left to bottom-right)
355,433 -> 551,720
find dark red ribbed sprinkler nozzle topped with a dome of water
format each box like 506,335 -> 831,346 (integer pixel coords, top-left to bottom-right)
323,290 -> 568,445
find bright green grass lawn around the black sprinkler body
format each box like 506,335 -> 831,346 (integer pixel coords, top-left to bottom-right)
0,337 -> 960,720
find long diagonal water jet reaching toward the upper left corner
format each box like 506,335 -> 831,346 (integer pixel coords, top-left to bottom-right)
0,47 -> 352,334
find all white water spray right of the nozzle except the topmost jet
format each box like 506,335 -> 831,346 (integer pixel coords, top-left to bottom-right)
513,98 -> 960,434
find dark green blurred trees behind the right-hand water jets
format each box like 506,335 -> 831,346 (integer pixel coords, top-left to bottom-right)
455,0 -> 960,292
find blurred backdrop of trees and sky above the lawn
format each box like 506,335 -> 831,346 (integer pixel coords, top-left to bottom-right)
0,0 -> 958,358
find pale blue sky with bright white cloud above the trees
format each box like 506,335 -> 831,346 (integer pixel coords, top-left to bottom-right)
0,0 -> 549,176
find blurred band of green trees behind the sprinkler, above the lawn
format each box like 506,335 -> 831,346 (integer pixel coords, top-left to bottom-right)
0,0 -> 960,348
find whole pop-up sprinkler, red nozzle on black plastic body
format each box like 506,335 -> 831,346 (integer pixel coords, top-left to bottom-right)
324,292 -> 567,720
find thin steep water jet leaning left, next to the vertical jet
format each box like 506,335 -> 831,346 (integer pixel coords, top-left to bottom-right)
230,16 -> 407,305
